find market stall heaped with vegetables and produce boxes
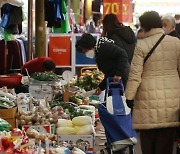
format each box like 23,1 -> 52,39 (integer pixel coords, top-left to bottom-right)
0,67 -> 104,154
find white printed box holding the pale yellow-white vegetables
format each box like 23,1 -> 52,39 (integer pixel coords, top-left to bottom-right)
58,135 -> 94,154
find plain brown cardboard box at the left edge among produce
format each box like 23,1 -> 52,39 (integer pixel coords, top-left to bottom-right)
0,107 -> 17,129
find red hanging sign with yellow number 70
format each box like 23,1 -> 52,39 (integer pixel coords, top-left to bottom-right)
103,0 -> 132,22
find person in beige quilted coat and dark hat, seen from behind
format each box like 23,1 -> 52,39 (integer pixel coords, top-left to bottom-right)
125,11 -> 180,154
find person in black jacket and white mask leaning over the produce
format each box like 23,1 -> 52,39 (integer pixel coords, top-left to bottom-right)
76,33 -> 130,95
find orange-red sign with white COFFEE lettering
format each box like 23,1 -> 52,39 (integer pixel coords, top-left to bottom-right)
48,36 -> 71,66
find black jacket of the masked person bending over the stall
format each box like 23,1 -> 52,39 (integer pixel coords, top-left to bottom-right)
96,43 -> 130,90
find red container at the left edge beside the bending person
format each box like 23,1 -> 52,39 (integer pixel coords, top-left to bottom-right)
0,73 -> 22,88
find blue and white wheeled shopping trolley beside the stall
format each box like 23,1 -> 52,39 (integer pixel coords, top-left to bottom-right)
98,78 -> 137,154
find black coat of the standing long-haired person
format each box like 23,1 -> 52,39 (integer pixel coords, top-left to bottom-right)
107,26 -> 136,64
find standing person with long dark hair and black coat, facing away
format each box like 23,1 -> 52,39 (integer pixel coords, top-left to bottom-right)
102,13 -> 136,63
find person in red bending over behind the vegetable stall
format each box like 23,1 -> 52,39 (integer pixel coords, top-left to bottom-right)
21,57 -> 56,74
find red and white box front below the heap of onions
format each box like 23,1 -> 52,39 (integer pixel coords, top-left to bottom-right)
22,124 -> 55,134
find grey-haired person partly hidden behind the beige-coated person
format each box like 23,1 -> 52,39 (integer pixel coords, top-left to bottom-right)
162,15 -> 180,38
